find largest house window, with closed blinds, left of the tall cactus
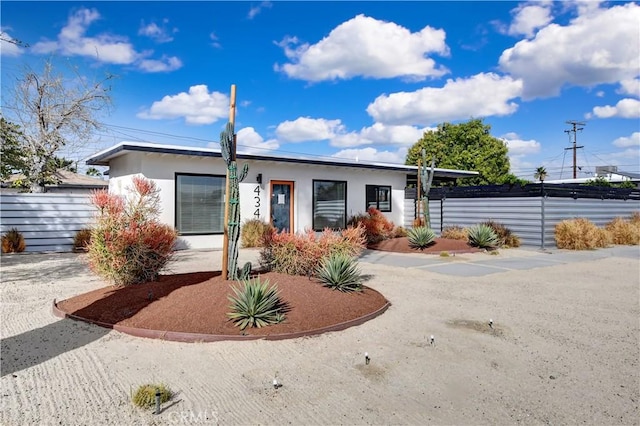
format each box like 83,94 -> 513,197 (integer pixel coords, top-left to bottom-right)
176,173 -> 226,235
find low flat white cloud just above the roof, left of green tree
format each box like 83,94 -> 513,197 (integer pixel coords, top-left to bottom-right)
330,123 -> 431,148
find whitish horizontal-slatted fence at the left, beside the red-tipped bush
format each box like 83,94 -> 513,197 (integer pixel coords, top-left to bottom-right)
0,193 -> 95,252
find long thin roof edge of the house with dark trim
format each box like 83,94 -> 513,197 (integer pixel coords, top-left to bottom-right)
86,142 -> 479,178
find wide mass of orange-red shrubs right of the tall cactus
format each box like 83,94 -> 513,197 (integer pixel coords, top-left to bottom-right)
260,225 -> 366,276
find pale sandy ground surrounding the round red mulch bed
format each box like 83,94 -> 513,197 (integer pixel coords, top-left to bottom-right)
0,247 -> 640,425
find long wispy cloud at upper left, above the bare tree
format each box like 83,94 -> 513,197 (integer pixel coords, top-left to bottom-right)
32,8 -> 182,72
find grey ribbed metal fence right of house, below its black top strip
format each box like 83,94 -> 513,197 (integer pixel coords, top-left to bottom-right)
405,197 -> 640,248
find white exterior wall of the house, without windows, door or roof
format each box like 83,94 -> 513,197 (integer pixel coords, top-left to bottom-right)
109,153 -> 406,249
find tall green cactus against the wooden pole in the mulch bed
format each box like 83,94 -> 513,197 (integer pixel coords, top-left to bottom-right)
220,123 -> 249,281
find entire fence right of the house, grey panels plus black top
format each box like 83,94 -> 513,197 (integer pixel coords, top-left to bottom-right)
404,185 -> 640,248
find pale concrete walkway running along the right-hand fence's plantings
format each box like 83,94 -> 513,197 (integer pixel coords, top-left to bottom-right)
360,246 -> 640,277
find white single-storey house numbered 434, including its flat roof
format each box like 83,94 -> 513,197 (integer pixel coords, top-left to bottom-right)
86,142 -> 478,249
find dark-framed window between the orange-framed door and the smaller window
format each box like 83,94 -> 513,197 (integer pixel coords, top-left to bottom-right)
313,180 -> 347,231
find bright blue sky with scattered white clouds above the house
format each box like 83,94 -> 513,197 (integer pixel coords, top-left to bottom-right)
0,1 -> 640,179
